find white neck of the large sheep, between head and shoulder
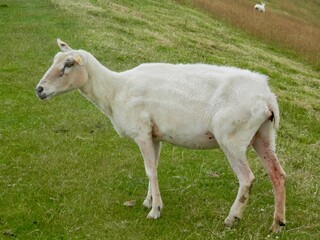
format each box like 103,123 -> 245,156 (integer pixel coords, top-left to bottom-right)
80,55 -> 118,118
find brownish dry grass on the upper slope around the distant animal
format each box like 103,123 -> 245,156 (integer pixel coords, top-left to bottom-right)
178,0 -> 320,69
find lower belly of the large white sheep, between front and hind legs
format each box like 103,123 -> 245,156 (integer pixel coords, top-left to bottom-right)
152,127 -> 219,149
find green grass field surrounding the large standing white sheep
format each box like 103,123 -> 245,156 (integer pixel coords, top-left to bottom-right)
0,0 -> 320,240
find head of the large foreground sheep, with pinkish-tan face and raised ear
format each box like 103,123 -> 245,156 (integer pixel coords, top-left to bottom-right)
36,39 -> 88,100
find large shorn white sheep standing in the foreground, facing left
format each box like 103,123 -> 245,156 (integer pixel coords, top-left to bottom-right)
36,39 -> 285,232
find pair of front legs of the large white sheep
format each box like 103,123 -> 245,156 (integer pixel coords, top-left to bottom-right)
136,136 -> 163,219
